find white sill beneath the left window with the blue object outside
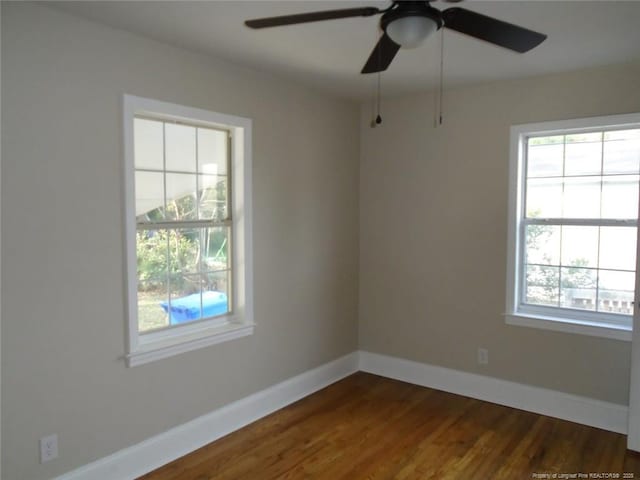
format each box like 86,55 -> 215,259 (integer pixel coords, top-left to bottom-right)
126,323 -> 255,367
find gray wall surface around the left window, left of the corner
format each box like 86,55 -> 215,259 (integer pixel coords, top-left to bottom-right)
2,3 -> 359,480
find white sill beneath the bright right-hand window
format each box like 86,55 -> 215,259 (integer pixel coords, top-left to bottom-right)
505,313 -> 631,342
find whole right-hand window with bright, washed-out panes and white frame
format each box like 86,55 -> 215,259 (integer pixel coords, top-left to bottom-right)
507,114 -> 640,340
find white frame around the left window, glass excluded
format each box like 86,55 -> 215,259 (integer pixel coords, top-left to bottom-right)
123,95 -> 255,367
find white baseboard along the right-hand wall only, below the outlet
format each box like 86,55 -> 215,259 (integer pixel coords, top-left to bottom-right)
359,351 -> 629,434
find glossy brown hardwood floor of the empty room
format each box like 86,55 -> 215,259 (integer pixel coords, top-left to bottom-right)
140,372 -> 640,480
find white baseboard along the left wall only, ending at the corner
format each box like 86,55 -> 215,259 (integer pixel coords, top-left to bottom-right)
57,352 -> 358,480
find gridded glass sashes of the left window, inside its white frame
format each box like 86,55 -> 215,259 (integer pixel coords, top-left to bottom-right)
134,116 -> 233,333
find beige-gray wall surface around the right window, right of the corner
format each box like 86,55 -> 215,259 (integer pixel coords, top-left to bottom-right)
359,60 -> 640,405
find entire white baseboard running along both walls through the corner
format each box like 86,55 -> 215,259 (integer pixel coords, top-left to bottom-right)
56,351 -> 628,480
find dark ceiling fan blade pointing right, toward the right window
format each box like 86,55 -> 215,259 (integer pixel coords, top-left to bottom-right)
442,7 -> 547,53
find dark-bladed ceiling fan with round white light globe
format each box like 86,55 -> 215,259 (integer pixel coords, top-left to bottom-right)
244,0 -> 547,73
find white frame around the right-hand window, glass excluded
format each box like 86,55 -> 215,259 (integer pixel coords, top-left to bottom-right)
505,113 -> 640,341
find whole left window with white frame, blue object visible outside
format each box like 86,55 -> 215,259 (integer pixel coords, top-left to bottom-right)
124,95 -> 253,366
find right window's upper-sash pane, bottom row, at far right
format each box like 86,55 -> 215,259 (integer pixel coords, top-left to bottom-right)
602,175 -> 640,219
